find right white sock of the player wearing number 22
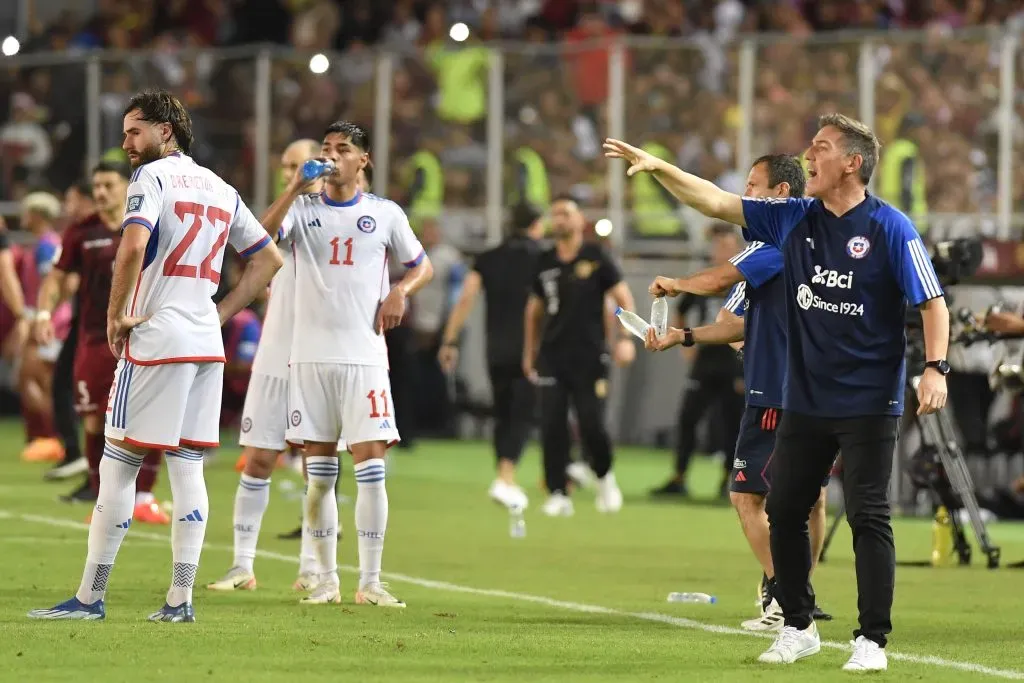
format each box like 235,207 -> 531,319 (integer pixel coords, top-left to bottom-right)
166,446 -> 210,607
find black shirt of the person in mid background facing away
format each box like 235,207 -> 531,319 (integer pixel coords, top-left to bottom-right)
473,238 -> 541,368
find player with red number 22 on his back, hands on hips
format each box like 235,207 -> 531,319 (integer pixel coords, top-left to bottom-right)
29,90 -> 282,622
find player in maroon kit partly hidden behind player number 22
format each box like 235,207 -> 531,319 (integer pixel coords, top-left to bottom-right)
33,162 -> 170,524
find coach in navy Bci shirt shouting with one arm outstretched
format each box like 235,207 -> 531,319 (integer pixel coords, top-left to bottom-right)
604,114 -> 949,671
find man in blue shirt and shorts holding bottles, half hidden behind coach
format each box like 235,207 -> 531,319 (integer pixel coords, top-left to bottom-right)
646,155 -> 831,631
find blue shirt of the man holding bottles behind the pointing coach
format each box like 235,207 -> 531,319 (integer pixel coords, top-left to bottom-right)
724,242 -> 786,408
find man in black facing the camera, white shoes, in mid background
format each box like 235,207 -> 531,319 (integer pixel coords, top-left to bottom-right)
522,198 -> 636,516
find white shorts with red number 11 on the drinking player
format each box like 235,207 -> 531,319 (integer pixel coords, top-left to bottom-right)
287,362 -> 400,446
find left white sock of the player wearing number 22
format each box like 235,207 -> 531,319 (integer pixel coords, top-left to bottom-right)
75,441 -> 142,605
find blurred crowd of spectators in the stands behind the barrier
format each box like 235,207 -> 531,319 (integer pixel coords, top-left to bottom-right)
0,0 -> 1024,222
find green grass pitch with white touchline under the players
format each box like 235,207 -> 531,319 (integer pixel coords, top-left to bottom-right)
0,423 -> 1024,683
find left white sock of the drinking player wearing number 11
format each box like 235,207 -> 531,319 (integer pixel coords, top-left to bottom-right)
303,456 -> 338,582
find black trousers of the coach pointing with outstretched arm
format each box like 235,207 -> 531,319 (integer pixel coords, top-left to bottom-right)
767,411 -> 899,647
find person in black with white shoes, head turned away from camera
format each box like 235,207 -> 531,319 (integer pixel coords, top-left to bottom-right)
437,205 -> 544,509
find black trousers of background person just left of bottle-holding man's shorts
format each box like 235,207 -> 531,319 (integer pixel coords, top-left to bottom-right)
676,375 -> 743,477
